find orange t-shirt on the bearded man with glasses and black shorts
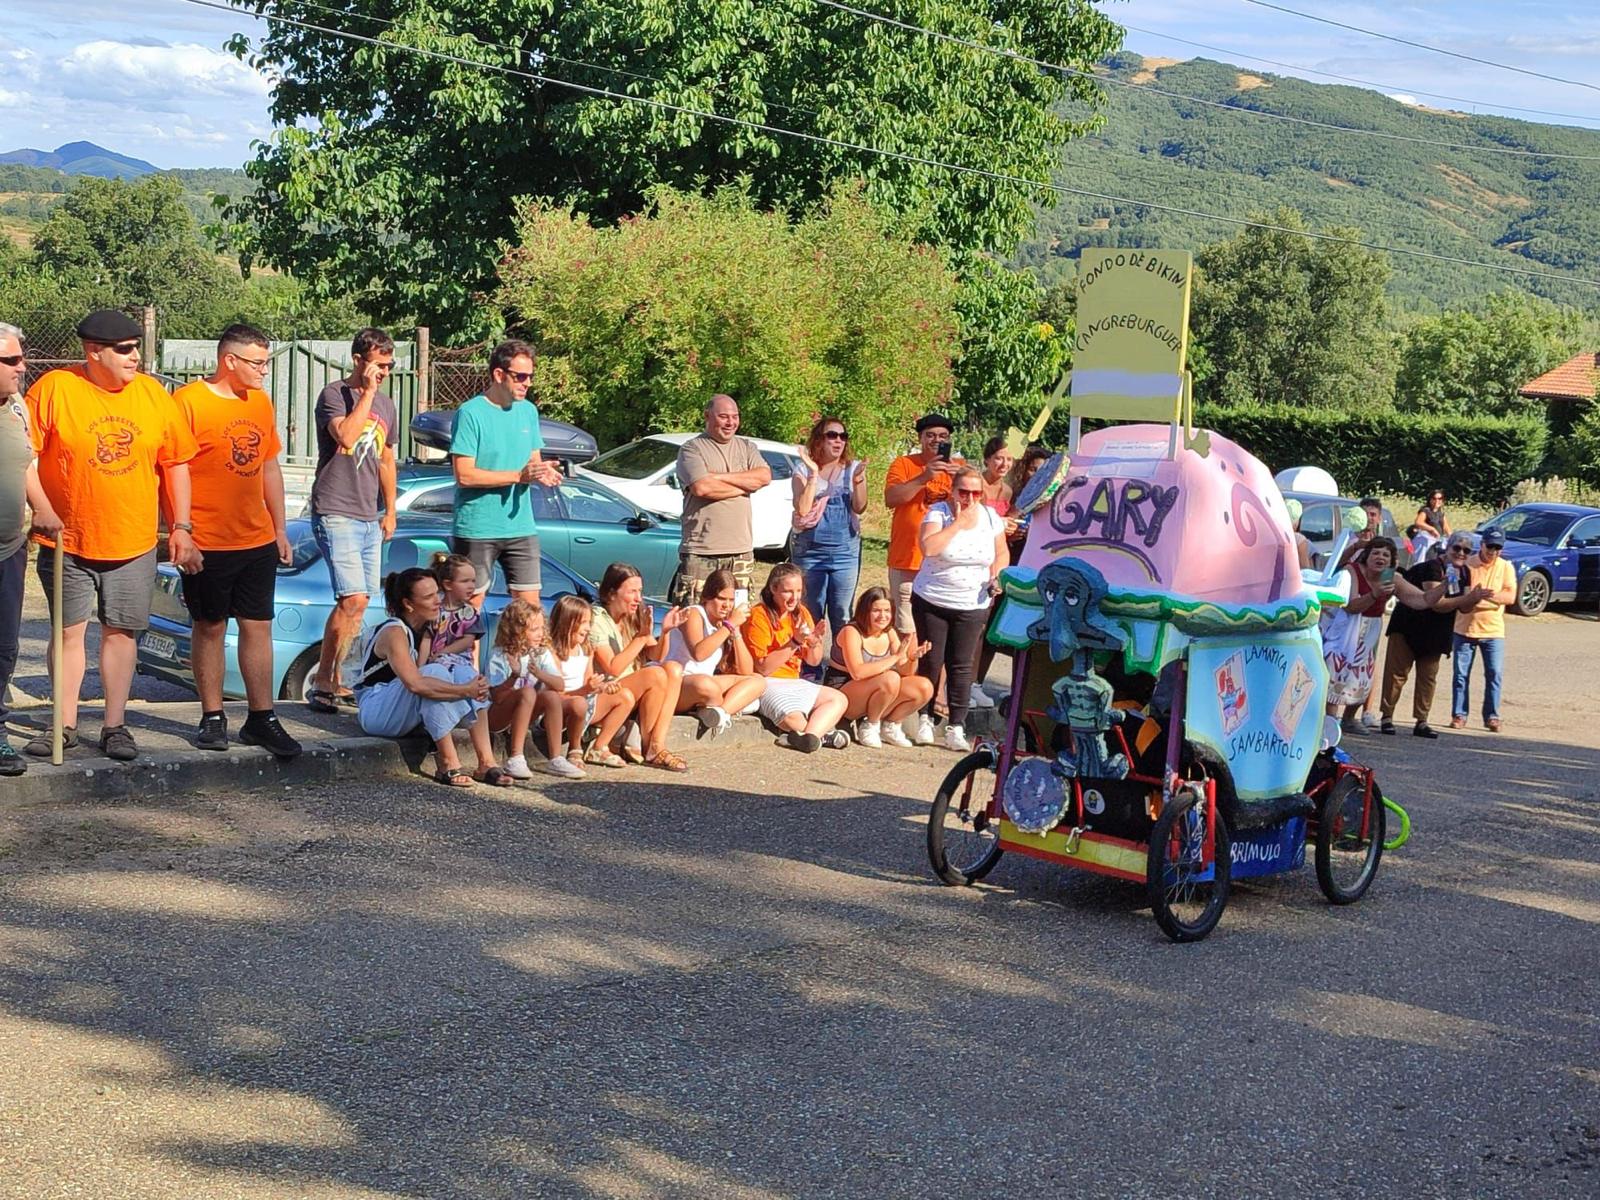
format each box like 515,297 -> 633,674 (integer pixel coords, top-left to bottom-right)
173,379 -> 283,550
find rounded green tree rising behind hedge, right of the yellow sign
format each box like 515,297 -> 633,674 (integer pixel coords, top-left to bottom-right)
1190,208 -> 1395,410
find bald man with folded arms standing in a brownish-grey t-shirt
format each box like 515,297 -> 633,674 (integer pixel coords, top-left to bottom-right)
670,395 -> 773,605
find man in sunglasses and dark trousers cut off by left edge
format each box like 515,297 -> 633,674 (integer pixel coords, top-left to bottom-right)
0,323 -> 43,776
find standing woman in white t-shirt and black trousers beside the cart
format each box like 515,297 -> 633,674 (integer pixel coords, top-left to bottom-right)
910,467 -> 1011,752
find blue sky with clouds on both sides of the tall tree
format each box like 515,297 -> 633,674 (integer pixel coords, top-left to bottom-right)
9,0 -> 1600,166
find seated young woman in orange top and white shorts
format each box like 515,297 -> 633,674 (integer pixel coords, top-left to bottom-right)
742,563 -> 850,754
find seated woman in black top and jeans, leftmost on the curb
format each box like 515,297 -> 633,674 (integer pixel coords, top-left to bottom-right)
355,566 -> 512,787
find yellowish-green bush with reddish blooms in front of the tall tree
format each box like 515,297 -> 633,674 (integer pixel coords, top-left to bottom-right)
496,187 -> 957,453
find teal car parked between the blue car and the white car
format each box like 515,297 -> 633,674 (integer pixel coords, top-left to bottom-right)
395,462 -> 683,595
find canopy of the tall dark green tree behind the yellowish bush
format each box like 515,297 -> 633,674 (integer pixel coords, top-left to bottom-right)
230,0 -> 1122,333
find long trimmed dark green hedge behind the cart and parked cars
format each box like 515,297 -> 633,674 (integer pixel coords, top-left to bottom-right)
1197,405 -> 1549,504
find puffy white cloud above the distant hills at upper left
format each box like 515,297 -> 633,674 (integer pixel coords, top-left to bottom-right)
59,40 -> 269,104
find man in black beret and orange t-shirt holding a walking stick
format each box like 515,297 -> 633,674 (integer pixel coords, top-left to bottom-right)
26,309 -> 200,762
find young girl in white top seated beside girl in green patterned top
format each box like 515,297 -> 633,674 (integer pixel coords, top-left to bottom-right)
531,595 -> 634,779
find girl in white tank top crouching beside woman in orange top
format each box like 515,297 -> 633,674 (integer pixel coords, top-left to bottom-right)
664,571 -> 766,741
